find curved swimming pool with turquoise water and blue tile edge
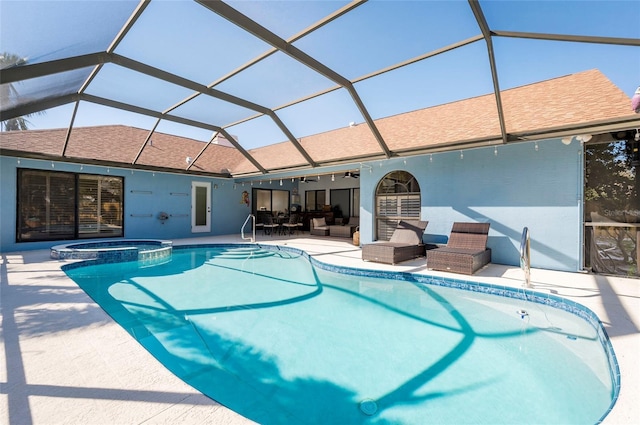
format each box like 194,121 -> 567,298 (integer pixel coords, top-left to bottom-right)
64,245 -> 619,424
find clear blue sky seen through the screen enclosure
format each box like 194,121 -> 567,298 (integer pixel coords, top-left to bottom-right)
0,0 -> 640,149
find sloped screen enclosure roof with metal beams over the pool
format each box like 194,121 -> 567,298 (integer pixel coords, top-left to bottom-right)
0,0 -> 640,175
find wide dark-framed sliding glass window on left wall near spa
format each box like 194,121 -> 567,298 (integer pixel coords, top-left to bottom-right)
16,169 -> 124,242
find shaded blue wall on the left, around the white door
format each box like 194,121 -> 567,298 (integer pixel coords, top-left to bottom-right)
0,157 -> 278,252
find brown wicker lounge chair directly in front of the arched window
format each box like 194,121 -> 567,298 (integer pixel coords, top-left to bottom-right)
362,220 -> 429,264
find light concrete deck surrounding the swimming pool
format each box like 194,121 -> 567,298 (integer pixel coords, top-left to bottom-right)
0,235 -> 640,425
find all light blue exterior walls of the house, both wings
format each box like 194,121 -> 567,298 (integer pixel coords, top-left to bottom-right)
0,139 -> 583,271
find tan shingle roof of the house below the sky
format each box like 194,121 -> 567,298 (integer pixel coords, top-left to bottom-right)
0,70 -> 638,175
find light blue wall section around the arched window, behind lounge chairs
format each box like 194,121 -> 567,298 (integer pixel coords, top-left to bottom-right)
360,139 -> 583,271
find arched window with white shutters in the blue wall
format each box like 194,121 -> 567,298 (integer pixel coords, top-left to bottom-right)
375,171 -> 420,241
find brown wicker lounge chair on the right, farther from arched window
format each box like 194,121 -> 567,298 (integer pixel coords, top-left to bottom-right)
427,222 -> 491,275
